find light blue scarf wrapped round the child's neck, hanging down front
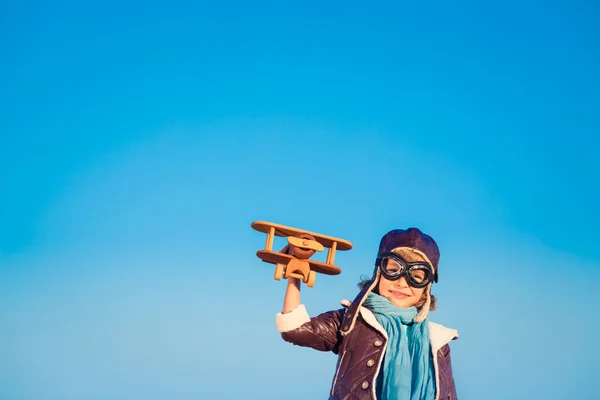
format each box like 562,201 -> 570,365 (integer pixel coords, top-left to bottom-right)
363,293 -> 435,400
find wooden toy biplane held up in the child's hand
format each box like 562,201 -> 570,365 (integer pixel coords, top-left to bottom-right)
251,221 -> 352,287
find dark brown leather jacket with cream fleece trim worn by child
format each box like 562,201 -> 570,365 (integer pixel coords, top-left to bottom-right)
276,293 -> 458,400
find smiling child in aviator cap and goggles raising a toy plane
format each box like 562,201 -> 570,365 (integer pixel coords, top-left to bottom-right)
276,228 -> 458,400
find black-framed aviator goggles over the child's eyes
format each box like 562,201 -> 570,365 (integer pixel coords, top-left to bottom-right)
378,253 -> 434,288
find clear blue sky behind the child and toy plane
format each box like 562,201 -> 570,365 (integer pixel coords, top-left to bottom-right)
0,0 -> 600,400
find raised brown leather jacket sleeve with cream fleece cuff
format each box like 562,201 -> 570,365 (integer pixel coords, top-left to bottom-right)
276,304 -> 344,354
